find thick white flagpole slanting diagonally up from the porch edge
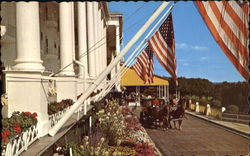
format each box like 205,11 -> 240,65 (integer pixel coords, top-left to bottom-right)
49,2 -> 170,136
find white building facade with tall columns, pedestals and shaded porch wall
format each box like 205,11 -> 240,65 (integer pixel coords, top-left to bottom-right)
1,2 -> 122,136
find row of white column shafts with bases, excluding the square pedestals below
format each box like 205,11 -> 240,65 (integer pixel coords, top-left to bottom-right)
13,2 -> 107,78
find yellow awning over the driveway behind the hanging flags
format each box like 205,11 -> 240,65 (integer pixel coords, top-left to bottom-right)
121,67 -> 169,86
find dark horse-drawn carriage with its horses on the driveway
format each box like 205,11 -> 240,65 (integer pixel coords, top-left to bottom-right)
140,99 -> 185,128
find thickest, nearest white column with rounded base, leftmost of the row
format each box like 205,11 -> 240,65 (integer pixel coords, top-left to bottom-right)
13,2 -> 44,71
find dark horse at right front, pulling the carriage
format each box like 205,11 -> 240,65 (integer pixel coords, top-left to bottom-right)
169,101 -> 187,130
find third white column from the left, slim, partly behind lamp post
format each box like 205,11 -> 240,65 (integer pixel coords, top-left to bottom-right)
78,2 -> 88,78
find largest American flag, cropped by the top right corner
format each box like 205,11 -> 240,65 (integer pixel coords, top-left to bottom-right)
195,1 -> 249,80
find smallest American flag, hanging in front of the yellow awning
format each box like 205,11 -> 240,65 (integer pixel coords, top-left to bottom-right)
133,46 -> 154,84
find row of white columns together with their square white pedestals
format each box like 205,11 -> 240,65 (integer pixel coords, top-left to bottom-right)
9,1 -> 107,136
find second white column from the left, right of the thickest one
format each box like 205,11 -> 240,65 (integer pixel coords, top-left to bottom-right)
59,2 -> 75,76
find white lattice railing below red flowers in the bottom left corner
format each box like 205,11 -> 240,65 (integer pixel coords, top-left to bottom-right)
2,125 -> 38,156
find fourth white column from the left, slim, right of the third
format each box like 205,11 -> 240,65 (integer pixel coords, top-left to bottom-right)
87,2 -> 95,78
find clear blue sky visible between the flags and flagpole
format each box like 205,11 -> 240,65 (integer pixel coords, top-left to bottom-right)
109,1 -> 244,82
